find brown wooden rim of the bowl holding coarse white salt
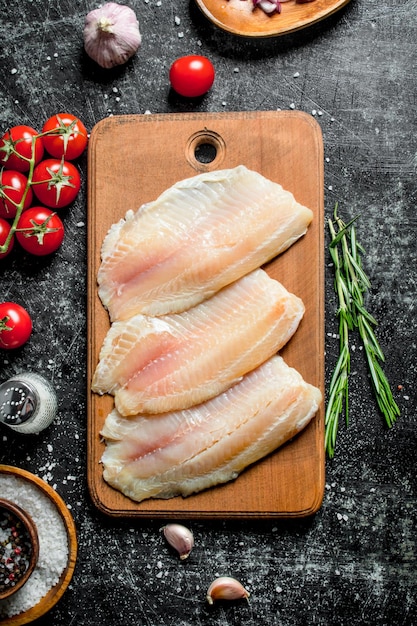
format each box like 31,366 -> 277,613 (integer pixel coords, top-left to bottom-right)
0,465 -> 78,626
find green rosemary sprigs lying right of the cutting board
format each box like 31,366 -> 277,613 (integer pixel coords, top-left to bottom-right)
325,204 -> 400,458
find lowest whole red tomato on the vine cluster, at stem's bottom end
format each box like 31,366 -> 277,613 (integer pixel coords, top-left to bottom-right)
15,206 -> 64,256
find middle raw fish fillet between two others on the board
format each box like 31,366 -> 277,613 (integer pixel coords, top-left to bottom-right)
92,269 -> 304,415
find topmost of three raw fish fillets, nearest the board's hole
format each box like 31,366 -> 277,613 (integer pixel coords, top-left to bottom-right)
97,165 -> 313,321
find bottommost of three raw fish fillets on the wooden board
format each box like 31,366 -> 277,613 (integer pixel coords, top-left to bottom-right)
101,356 -> 322,502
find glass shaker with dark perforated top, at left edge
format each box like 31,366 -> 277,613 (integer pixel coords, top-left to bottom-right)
0,372 -> 58,434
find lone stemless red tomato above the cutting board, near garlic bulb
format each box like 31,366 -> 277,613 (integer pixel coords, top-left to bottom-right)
169,55 -> 215,98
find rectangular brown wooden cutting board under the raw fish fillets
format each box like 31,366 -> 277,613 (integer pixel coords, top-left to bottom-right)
87,111 -> 325,519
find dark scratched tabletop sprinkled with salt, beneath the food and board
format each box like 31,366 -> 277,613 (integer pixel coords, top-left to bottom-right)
0,0 -> 417,626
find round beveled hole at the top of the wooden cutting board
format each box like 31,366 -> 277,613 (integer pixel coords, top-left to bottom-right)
185,128 -> 226,172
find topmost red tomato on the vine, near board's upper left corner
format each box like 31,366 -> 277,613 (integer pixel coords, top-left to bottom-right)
42,113 -> 88,161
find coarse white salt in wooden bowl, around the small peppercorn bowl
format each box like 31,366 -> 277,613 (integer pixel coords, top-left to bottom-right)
0,474 -> 69,620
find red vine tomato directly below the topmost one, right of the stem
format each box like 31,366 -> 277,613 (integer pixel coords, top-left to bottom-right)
32,158 -> 81,209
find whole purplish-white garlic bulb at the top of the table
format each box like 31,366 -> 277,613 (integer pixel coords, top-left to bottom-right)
83,2 -> 142,68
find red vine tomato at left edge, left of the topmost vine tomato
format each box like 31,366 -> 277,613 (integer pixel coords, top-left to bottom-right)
0,126 -> 44,172
